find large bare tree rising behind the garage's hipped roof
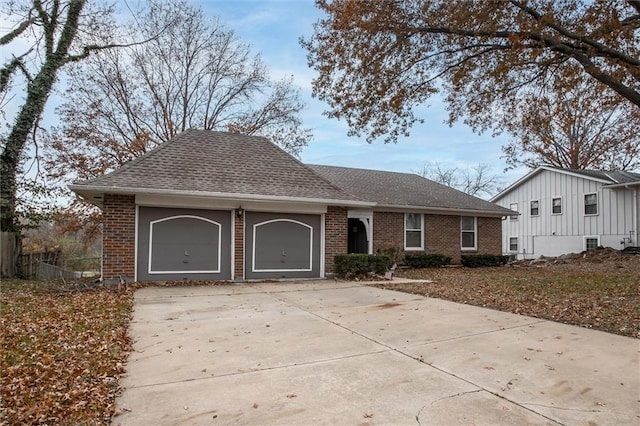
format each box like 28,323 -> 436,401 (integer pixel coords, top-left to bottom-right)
47,0 -> 311,180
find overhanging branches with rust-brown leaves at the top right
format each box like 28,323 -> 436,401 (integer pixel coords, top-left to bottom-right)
302,0 -> 640,142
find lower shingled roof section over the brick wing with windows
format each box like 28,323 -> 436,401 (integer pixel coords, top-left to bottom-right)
309,165 -> 512,215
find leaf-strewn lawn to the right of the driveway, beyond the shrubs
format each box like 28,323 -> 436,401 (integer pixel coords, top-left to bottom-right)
377,257 -> 640,338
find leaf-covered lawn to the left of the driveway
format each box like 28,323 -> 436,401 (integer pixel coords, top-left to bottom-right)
0,280 -> 133,425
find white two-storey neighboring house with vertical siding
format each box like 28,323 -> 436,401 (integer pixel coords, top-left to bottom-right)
491,167 -> 640,259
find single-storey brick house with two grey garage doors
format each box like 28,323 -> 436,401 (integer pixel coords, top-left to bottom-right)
70,130 -> 512,281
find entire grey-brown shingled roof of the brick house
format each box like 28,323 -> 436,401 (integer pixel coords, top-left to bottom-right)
70,130 -> 512,215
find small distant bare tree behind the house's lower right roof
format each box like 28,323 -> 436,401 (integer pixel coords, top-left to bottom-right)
418,161 -> 501,197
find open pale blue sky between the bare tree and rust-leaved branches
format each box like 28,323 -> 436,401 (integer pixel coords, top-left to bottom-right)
198,0 -> 524,190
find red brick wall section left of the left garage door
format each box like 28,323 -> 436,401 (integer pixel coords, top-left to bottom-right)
102,194 -> 136,280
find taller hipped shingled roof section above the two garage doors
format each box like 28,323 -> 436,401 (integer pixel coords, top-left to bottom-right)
71,130 -> 361,203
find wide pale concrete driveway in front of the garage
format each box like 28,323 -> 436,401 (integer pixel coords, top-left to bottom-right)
113,281 -> 640,425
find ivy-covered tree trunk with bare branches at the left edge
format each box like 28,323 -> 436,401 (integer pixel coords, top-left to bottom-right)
0,0 -> 152,232
